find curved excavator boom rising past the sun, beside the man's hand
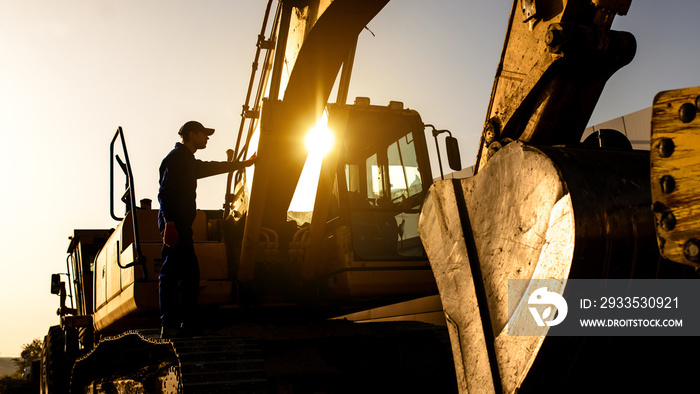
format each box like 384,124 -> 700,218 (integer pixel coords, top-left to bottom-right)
238,0 -> 388,282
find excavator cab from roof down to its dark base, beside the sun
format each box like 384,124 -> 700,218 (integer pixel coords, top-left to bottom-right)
302,98 -> 446,299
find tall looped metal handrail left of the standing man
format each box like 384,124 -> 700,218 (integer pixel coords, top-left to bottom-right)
109,126 -> 148,280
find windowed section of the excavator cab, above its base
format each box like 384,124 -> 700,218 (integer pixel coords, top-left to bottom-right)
338,103 -> 431,260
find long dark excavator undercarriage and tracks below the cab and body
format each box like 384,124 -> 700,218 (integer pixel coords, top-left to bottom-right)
71,321 -> 456,394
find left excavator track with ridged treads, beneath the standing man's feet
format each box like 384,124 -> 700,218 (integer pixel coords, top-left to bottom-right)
71,330 -> 268,394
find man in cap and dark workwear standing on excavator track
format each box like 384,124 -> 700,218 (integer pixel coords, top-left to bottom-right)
158,121 -> 255,338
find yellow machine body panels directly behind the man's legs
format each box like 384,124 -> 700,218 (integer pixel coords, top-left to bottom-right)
89,209 -> 233,332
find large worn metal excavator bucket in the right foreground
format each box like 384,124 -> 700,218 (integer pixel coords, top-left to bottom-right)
419,142 -> 680,393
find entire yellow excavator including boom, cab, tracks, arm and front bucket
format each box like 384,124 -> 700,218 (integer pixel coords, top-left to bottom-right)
41,0 -> 700,393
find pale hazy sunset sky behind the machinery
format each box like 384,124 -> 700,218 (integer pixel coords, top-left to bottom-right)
0,0 -> 700,357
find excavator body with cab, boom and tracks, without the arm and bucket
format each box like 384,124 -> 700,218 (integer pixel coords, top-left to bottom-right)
41,1 -> 456,393
